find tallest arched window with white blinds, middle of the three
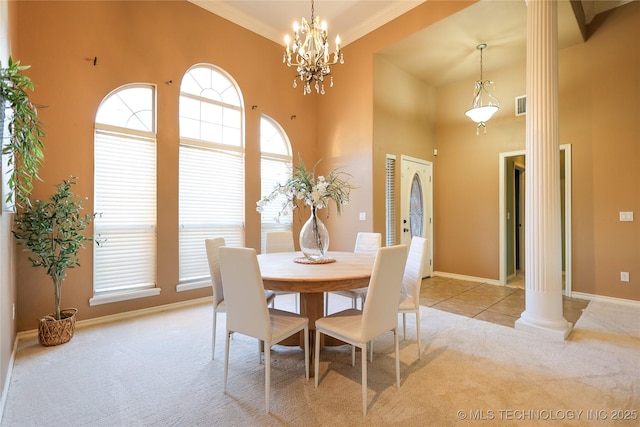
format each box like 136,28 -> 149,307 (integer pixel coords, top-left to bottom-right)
178,64 -> 244,290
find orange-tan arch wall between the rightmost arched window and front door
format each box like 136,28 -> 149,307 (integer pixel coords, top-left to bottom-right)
318,1 -> 475,250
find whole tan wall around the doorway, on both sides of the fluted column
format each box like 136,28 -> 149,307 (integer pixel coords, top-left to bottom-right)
434,2 -> 640,300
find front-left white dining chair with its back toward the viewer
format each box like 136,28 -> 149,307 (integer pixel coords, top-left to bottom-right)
219,246 -> 309,413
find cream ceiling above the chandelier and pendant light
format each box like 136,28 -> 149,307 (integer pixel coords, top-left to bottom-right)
189,0 -> 632,87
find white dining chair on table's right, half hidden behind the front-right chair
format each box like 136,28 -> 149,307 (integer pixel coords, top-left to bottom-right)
398,236 -> 427,359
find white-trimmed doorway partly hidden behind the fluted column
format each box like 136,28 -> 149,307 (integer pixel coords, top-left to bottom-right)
500,144 -> 571,296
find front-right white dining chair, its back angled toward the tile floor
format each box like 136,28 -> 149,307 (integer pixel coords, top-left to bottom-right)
314,245 -> 407,415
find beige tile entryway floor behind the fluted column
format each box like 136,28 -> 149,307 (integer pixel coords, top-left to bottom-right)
420,277 -> 589,328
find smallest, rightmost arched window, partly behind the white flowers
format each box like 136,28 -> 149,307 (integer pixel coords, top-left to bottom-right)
260,115 -> 293,252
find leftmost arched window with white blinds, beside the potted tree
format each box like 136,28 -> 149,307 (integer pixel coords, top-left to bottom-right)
91,84 -> 159,298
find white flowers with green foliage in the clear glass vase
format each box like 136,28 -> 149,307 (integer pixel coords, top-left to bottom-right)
256,157 -> 355,222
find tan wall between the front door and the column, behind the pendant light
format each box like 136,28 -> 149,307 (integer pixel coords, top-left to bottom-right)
433,64 -> 525,280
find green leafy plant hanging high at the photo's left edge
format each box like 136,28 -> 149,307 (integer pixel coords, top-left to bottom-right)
0,57 -> 45,207
